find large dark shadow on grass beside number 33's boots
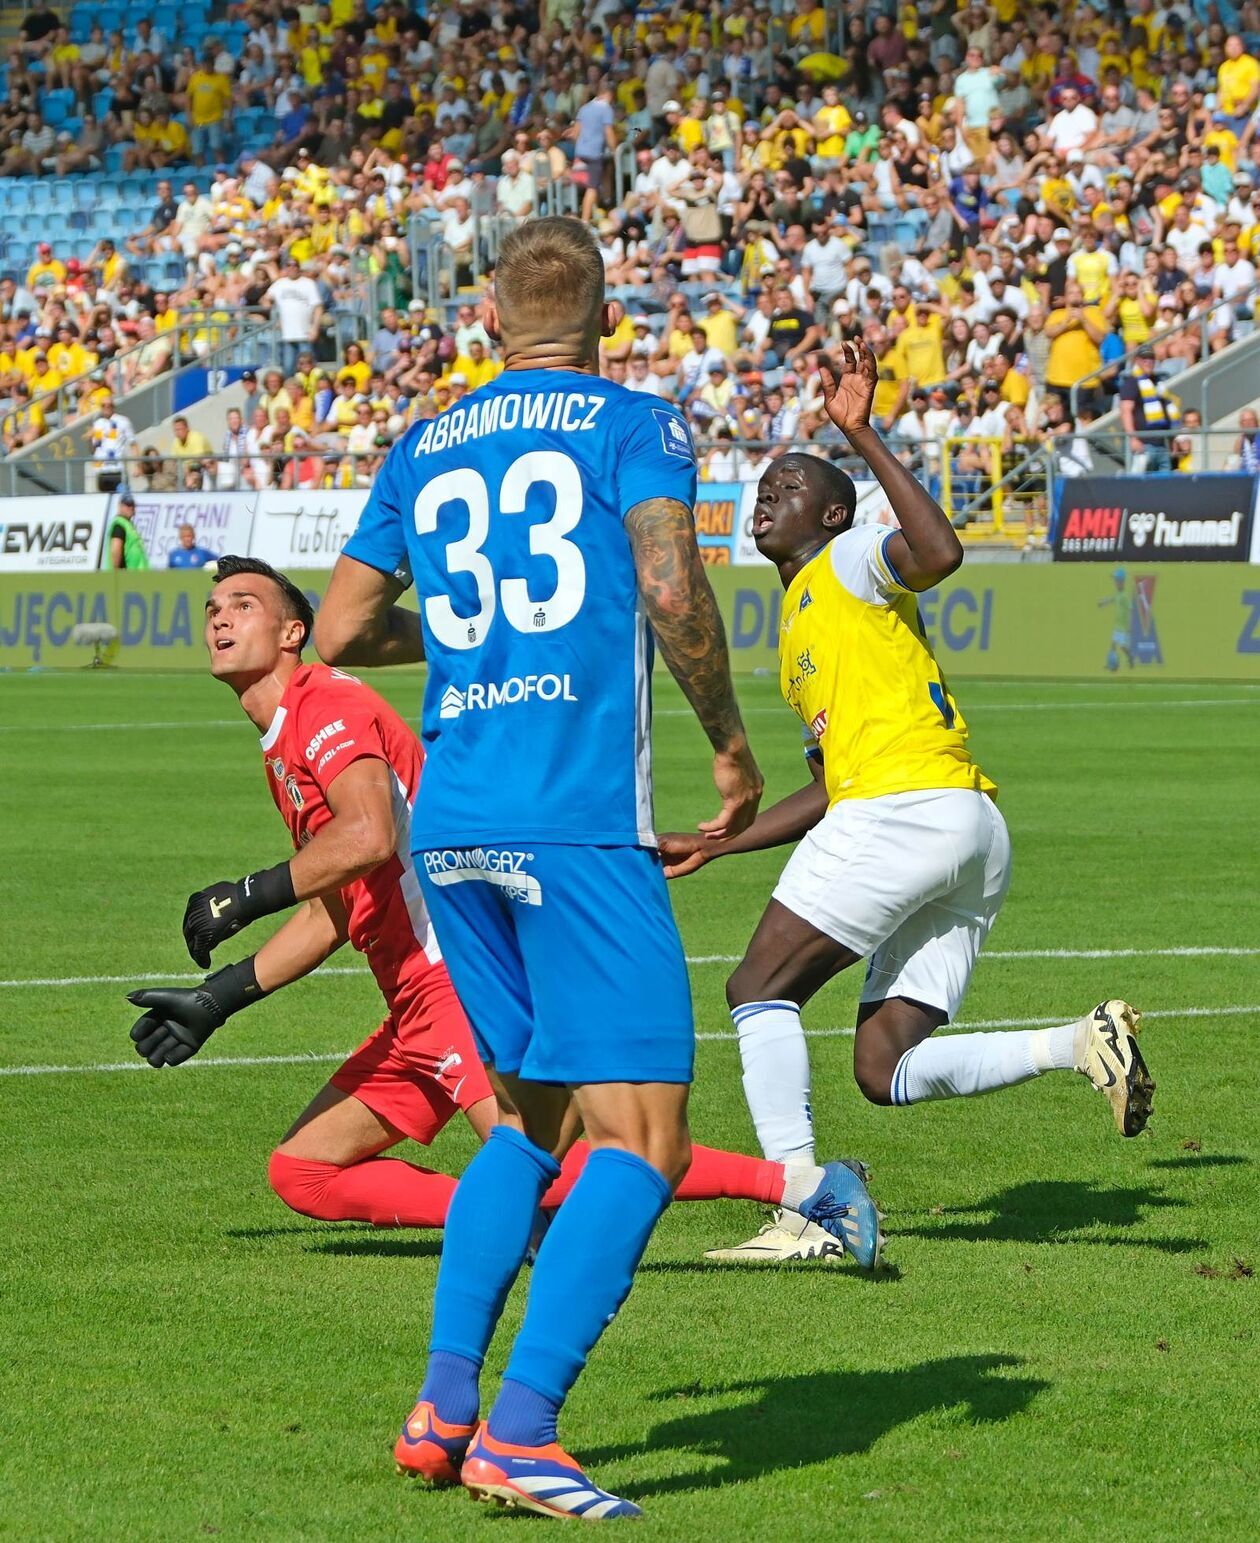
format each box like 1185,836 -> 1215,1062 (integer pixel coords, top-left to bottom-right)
581,1355 -> 1049,1498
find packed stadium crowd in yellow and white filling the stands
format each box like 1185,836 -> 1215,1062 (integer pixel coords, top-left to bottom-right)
0,0 -> 1260,503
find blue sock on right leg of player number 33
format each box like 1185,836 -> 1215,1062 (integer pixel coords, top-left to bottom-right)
489,1146 -> 669,1446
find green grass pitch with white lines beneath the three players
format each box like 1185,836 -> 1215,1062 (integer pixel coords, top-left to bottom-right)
0,671 -> 1260,1543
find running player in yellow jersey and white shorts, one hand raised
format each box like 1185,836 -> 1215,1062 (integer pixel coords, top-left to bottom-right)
660,343 -> 1155,1261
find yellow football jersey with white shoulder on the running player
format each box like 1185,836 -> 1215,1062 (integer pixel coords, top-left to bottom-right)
779,525 -> 996,807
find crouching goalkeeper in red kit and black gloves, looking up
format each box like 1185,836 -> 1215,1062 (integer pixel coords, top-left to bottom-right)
128,557 -> 842,1277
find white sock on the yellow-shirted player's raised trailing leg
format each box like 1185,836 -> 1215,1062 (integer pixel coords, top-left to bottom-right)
893,1023 -> 1076,1105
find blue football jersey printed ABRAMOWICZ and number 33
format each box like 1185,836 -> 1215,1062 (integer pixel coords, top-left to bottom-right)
345,370 -> 696,849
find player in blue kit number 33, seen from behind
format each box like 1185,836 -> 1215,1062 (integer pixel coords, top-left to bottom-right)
315,219 -> 874,1520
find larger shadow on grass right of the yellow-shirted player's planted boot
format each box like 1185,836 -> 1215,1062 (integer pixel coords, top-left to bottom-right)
891,1179 -> 1204,1253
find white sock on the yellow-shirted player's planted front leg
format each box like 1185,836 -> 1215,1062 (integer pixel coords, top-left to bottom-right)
731,1001 -> 814,1165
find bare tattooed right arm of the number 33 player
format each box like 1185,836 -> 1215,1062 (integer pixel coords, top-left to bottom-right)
626,498 -> 762,841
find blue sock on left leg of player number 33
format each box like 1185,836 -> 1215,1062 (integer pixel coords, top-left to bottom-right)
419,1125 -> 560,1424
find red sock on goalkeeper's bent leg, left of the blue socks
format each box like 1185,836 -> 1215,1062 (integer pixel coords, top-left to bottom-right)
267,1153 -> 455,1227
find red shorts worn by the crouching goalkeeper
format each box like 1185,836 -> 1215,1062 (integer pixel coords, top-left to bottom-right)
332,964 -> 494,1146
